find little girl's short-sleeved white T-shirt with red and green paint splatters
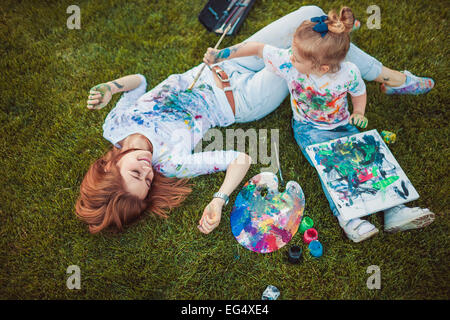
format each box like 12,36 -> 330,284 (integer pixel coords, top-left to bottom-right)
263,45 -> 366,130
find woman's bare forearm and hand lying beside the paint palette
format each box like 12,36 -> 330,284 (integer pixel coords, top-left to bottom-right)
198,153 -> 252,234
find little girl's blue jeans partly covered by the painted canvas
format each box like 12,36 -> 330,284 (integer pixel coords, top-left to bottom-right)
292,119 -> 359,216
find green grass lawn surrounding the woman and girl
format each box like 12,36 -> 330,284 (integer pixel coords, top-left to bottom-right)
0,0 -> 450,300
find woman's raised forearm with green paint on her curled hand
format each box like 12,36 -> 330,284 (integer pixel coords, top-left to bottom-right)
87,74 -> 141,109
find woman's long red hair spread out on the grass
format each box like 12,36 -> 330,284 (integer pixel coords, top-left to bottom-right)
75,146 -> 191,233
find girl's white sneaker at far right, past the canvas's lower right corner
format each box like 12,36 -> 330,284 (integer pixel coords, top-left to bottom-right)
384,205 -> 434,232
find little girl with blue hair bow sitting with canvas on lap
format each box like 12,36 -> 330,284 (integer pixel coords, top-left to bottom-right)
204,7 -> 434,242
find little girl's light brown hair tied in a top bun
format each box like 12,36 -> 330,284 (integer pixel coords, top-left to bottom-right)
293,7 -> 355,73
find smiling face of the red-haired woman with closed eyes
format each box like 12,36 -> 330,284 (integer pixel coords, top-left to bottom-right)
117,150 -> 153,199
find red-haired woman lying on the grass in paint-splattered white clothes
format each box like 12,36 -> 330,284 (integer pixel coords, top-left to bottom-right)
75,6 -> 433,233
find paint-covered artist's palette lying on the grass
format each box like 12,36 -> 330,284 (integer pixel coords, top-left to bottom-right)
230,172 -> 305,253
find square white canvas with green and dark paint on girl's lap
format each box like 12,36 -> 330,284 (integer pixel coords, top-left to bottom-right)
306,130 -> 419,220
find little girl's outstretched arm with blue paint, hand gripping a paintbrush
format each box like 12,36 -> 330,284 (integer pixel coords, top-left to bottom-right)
203,41 -> 264,65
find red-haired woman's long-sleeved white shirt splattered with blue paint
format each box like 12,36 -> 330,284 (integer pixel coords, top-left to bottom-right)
103,67 -> 239,178
